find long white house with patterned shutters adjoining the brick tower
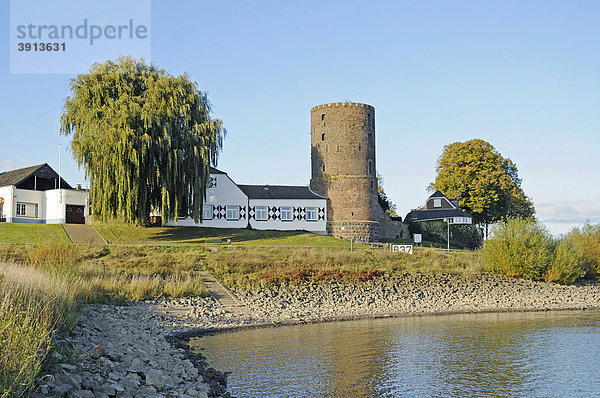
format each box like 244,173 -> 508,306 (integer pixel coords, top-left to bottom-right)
165,168 -> 327,234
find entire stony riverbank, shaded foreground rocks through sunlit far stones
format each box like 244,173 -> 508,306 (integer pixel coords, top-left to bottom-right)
40,274 -> 600,397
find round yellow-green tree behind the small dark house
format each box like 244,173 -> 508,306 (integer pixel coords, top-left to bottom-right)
430,139 -> 535,235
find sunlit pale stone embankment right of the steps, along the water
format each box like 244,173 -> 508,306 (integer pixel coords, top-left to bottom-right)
237,274 -> 600,322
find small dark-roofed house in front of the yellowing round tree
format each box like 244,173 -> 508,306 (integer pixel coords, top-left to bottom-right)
404,191 -> 473,224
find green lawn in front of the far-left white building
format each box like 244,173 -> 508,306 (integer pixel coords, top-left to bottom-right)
0,223 -> 70,243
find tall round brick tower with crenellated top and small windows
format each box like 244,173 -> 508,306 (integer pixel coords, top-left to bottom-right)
310,102 -> 382,241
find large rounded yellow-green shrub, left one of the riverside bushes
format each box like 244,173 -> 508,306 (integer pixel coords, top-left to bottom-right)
482,218 -> 554,280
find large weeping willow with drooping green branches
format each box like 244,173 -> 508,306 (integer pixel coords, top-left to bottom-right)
61,57 -> 225,223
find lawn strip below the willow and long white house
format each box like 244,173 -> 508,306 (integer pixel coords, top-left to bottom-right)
94,223 -> 350,247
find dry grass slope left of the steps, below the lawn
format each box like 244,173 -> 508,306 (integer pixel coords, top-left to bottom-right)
0,243 -> 207,302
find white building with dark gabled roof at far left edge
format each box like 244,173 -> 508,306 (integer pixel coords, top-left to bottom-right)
0,163 -> 89,224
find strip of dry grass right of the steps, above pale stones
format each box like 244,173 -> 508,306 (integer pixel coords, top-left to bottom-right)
206,247 -> 483,289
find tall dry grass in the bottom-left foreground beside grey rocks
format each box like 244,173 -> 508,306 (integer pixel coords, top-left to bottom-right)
0,262 -> 86,397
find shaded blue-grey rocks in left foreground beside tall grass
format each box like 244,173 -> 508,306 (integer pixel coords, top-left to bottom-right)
32,302 -> 228,398
